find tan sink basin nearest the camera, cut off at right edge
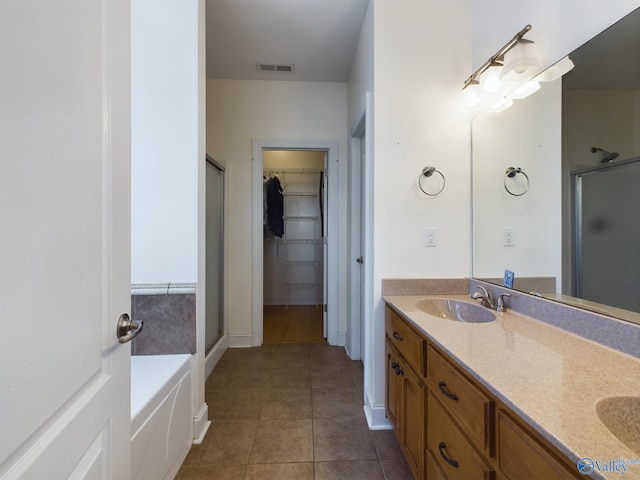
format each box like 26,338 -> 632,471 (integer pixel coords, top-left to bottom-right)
596,396 -> 640,455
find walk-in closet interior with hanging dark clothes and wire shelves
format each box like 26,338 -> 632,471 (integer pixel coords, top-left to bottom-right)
263,150 -> 326,343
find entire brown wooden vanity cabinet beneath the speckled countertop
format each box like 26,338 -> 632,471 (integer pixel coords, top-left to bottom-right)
385,305 -> 584,480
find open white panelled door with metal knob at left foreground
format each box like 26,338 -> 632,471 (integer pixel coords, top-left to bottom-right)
0,0 -> 130,480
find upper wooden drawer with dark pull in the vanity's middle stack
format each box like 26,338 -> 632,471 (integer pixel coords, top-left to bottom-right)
427,346 -> 495,456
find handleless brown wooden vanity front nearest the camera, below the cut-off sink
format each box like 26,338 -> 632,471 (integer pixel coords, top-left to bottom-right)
498,410 -> 580,480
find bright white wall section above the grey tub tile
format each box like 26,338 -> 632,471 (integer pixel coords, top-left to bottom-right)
131,0 -> 199,283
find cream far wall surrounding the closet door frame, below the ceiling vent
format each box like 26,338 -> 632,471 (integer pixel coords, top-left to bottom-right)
207,79 -> 348,345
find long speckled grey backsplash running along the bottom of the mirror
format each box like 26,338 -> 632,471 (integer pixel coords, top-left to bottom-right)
469,279 -> 640,358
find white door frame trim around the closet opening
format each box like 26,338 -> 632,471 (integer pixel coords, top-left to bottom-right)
251,139 -> 339,347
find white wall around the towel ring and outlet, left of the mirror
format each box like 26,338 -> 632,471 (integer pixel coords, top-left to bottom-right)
349,0 -> 471,428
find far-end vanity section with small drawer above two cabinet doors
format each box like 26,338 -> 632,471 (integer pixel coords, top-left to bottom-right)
385,307 -> 427,480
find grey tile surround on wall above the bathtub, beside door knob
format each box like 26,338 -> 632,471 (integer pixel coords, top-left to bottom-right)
131,288 -> 196,355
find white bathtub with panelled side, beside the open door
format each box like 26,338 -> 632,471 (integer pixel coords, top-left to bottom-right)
131,354 -> 193,480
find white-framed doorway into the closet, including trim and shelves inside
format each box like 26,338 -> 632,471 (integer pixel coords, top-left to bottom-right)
252,140 -> 338,346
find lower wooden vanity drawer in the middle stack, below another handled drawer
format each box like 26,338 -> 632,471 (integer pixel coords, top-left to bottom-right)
427,391 -> 496,480
